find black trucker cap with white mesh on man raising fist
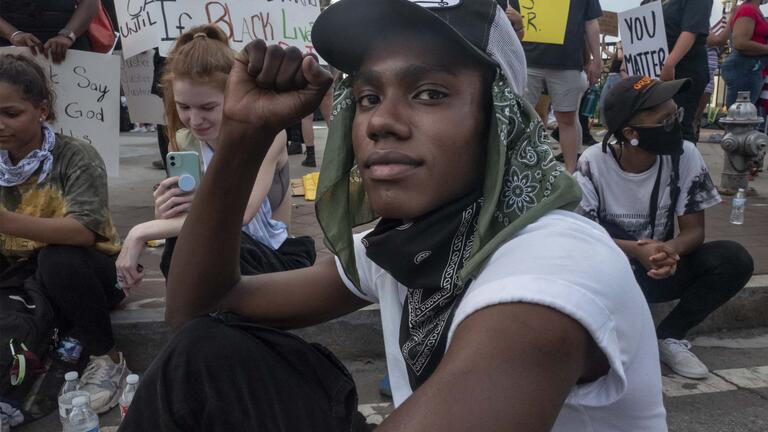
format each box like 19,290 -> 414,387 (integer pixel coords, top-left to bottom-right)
312,0 -> 499,73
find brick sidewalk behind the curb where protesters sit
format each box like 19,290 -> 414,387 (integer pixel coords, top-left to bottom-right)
110,122 -> 768,323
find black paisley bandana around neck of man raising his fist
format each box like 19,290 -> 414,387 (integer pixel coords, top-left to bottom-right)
363,192 -> 482,390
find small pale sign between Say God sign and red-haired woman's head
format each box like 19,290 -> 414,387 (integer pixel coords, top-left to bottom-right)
120,50 -> 165,124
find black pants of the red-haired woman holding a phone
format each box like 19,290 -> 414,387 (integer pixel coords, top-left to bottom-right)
160,232 -> 317,279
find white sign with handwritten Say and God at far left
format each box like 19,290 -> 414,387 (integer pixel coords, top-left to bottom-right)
0,47 -> 120,176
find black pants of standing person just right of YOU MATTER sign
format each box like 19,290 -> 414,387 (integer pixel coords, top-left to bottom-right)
675,44 -> 709,144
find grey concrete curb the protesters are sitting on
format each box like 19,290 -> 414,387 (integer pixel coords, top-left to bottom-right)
112,275 -> 768,372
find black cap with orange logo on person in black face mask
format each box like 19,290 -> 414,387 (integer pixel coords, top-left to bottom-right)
603,75 -> 692,144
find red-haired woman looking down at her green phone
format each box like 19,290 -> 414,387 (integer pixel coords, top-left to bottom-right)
117,25 -> 315,289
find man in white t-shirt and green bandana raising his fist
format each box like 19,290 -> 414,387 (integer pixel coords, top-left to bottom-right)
121,0 -> 667,432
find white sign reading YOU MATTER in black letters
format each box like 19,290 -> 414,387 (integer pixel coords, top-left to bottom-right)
619,2 -> 669,78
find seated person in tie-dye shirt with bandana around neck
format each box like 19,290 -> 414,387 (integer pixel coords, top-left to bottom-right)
0,54 -> 129,413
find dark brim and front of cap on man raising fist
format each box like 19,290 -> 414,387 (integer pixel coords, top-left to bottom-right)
312,0 -> 495,74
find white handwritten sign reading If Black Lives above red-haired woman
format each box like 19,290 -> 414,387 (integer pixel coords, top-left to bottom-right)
115,0 -> 320,58
